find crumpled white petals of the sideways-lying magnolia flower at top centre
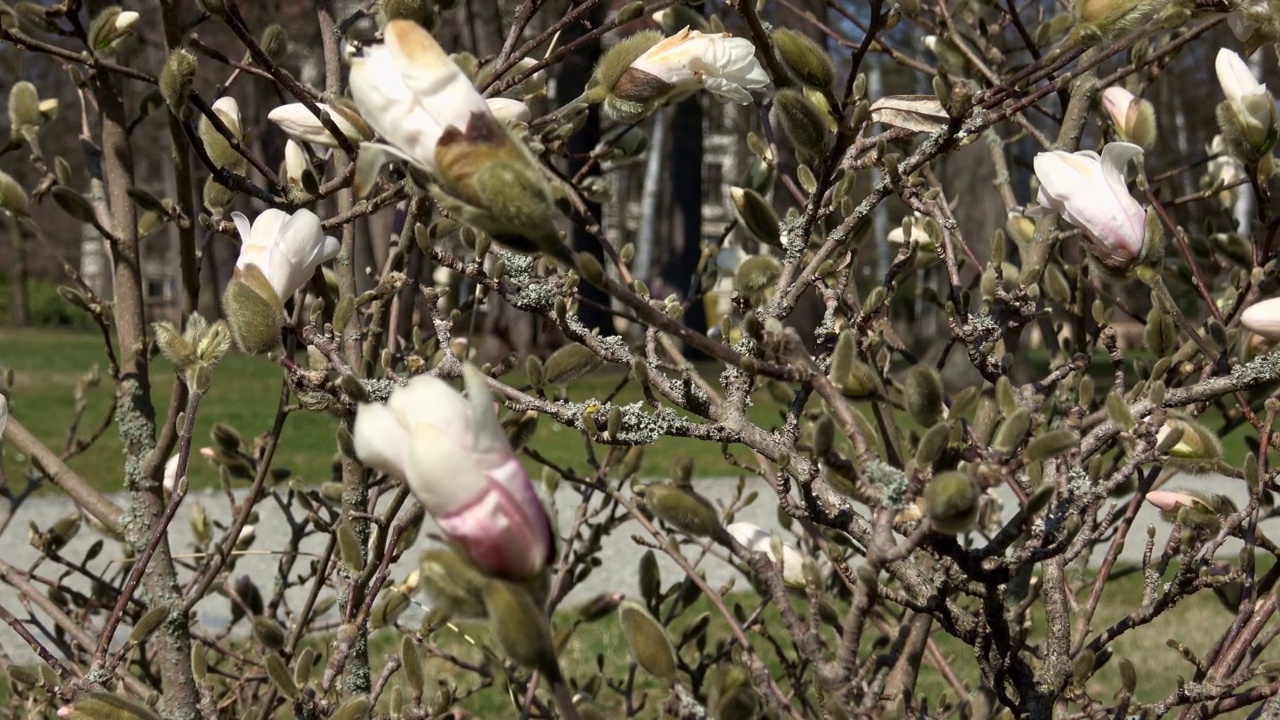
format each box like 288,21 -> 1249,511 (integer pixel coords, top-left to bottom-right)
614,27 -> 769,105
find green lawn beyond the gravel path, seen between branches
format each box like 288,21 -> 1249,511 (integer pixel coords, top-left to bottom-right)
0,331 -> 798,489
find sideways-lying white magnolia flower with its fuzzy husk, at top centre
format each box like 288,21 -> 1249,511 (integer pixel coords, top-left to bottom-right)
593,27 -> 769,122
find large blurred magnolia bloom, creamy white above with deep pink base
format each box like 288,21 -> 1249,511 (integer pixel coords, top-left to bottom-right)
353,365 -> 554,580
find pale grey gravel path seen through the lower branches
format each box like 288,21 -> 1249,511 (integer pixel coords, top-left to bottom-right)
0,478 -> 1259,661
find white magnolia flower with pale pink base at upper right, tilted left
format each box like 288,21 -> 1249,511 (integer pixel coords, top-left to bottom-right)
1029,142 -> 1147,268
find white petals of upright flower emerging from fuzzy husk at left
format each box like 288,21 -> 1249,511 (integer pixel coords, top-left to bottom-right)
232,209 -> 342,302
